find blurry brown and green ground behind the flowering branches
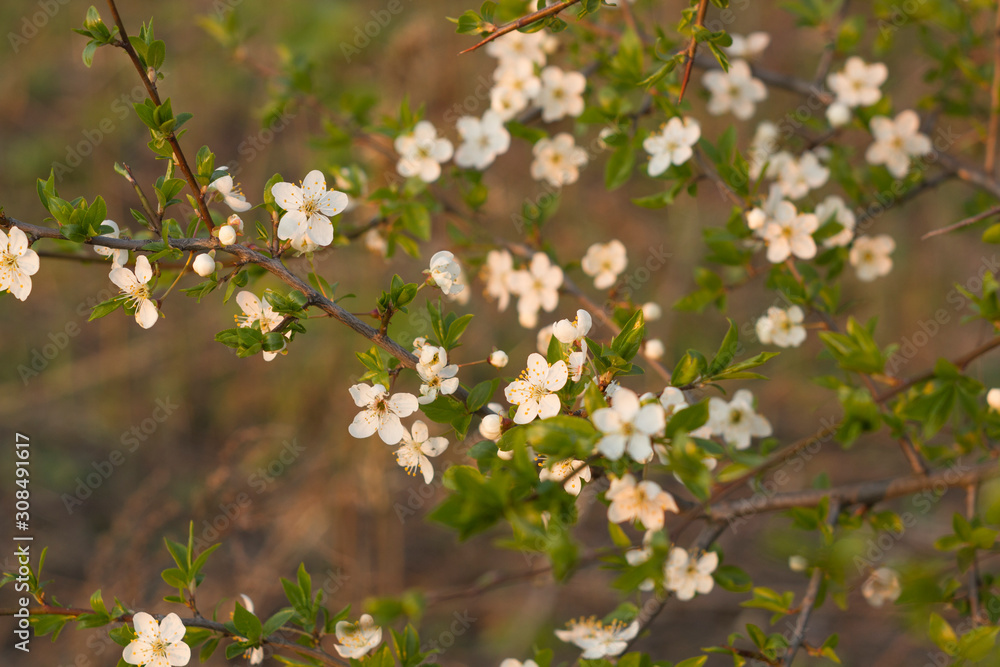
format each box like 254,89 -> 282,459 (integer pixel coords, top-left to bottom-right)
0,0 -> 1000,667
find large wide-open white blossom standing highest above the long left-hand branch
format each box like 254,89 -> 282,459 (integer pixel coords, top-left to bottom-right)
271,169 -> 347,246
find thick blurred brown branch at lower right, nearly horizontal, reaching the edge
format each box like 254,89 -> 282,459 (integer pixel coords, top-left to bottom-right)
706,461 -> 1000,521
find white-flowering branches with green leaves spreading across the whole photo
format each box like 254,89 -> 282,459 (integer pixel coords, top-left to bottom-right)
0,0 -> 1000,667
